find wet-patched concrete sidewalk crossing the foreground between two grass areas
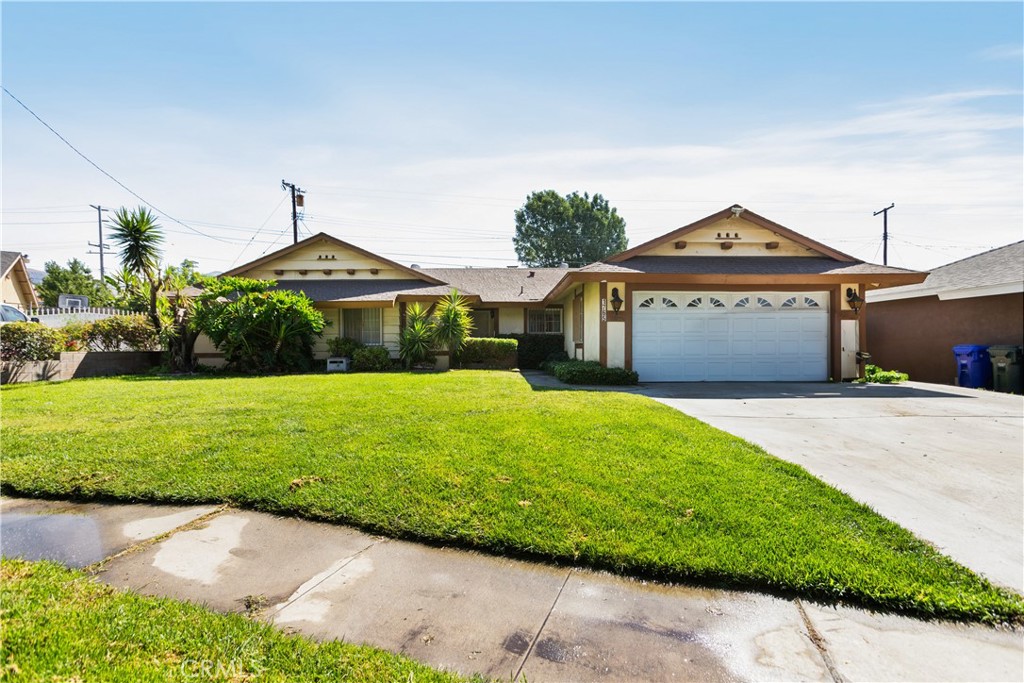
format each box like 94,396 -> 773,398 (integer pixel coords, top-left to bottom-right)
0,499 -> 1024,681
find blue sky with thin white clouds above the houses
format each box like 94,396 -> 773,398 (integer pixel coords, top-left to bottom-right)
2,2 -> 1024,271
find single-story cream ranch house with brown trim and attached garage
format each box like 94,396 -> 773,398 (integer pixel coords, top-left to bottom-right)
218,206 -> 927,381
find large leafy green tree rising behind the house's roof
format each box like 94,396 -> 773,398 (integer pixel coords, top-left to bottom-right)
512,189 -> 628,267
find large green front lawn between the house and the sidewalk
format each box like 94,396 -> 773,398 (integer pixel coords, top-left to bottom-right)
0,371 -> 1024,623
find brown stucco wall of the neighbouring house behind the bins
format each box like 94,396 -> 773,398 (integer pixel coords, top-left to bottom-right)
865,294 -> 1024,384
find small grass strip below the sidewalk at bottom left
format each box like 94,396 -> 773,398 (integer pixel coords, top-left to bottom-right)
0,559 -> 464,683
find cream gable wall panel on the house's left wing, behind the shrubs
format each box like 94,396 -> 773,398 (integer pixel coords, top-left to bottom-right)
242,241 -> 416,280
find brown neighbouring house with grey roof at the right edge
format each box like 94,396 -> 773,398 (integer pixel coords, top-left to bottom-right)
867,242 -> 1024,384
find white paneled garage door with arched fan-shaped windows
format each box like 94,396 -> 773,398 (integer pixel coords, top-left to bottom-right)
633,292 -> 828,382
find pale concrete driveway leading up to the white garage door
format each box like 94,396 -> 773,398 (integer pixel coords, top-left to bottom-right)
634,382 -> 1024,592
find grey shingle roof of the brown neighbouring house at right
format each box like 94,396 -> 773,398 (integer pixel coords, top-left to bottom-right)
868,241 -> 1024,301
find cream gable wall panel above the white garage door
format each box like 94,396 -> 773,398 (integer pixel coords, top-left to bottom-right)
642,218 -> 820,256
